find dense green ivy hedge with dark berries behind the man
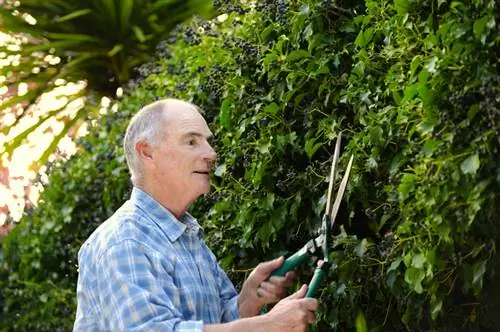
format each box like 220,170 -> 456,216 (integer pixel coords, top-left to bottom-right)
0,0 -> 500,331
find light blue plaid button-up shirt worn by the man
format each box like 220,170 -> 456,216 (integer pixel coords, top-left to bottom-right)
74,188 -> 239,332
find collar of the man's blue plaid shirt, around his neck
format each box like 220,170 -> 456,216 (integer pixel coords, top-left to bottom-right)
130,187 -> 203,242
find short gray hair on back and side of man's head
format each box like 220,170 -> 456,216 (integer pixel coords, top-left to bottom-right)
123,100 -> 168,185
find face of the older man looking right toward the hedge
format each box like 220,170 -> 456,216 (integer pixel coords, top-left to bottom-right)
152,105 -> 216,202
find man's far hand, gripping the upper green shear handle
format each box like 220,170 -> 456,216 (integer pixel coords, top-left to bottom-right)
238,256 -> 295,318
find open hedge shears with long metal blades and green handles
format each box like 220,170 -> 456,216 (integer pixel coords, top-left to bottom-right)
271,134 -> 354,297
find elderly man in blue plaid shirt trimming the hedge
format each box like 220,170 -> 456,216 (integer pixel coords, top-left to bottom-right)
74,99 -> 318,332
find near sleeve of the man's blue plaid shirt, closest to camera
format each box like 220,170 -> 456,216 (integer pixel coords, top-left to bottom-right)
96,240 -> 203,332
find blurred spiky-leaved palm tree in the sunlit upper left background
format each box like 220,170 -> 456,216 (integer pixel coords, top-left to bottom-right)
0,0 -> 212,165
